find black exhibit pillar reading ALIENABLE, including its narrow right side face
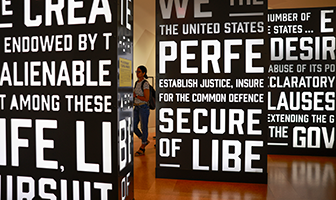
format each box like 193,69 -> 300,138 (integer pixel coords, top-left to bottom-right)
0,0 -> 134,200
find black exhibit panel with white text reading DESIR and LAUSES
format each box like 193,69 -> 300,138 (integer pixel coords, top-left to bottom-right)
267,7 -> 336,156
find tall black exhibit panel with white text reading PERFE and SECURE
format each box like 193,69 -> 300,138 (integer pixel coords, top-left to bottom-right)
156,0 -> 269,183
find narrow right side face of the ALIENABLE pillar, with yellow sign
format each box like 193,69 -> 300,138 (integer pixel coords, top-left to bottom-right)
117,0 -> 134,200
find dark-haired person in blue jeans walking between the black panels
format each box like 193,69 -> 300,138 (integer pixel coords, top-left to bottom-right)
133,65 -> 150,156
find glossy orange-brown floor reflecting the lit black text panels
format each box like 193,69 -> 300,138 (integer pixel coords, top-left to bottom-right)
134,134 -> 336,200
